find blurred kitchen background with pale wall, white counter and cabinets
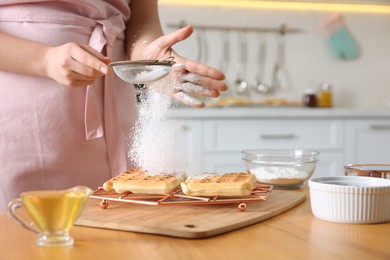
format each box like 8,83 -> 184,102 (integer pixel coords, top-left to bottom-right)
159,0 -> 390,176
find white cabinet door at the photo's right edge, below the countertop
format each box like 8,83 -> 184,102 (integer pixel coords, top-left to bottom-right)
346,119 -> 390,164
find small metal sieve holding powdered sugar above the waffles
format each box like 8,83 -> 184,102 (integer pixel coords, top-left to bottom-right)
109,57 -> 175,84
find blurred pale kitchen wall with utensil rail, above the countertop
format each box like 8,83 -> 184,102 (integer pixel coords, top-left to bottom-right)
159,0 -> 390,108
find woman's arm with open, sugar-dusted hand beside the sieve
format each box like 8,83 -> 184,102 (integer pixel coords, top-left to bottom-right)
126,0 -> 227,107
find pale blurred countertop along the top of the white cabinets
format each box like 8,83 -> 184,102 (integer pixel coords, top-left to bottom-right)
170,106 -> 390,119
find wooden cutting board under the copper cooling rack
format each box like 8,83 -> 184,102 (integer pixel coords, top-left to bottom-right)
76,190 -> 306,238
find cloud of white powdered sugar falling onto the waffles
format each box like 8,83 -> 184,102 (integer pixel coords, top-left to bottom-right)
128,89 -> 188,174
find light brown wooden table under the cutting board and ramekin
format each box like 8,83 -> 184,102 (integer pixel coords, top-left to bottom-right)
0,189 -> 390,260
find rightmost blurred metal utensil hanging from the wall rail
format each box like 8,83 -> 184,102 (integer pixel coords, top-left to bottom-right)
272,25 -> 289,89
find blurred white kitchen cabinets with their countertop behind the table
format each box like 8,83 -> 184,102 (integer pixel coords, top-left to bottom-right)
172,108 -> 390,176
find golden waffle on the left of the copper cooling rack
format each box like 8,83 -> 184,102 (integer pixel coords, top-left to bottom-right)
103,169 -> 182,194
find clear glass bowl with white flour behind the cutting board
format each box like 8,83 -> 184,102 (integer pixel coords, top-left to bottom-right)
242,149 -> 319,189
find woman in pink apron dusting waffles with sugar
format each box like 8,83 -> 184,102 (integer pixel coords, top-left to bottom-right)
0,0 -> 227,212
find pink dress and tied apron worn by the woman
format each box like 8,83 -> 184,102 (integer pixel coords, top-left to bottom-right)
0,0 -> 136,212
